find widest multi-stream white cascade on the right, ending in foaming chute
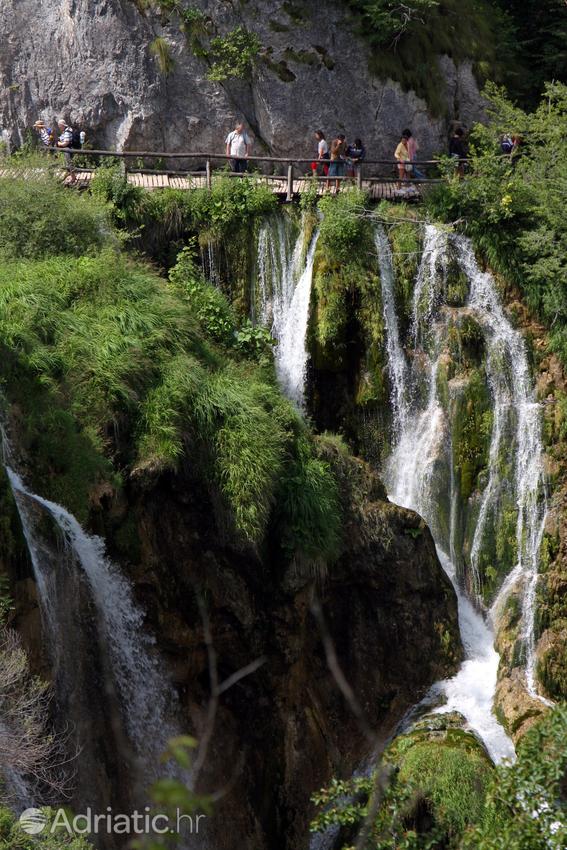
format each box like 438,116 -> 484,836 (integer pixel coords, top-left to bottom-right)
376,225 -> 545,760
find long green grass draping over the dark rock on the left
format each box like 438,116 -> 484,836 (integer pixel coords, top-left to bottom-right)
0,175 -> 340,558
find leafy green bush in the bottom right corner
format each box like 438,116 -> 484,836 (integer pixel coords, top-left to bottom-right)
465,705 -> 567,850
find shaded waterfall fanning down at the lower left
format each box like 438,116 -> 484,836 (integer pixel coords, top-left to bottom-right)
2,434 -> 176,806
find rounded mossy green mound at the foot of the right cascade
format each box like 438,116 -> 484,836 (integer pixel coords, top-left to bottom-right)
311,720 -> 492,850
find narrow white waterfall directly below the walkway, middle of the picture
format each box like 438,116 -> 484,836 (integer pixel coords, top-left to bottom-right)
258,216 -> 319,409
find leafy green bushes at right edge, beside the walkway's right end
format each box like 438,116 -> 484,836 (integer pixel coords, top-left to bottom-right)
427,84 -> 567,364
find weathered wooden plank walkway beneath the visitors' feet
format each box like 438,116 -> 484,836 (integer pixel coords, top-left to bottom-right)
0,168 -> 421,201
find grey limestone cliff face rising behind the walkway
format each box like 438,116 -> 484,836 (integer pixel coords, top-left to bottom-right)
0,0 -> 488,158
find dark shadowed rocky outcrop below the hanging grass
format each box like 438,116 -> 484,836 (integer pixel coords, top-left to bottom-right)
5,444 -> 460,850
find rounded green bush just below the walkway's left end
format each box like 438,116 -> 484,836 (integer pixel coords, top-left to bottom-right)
0,177 -> 109,259
